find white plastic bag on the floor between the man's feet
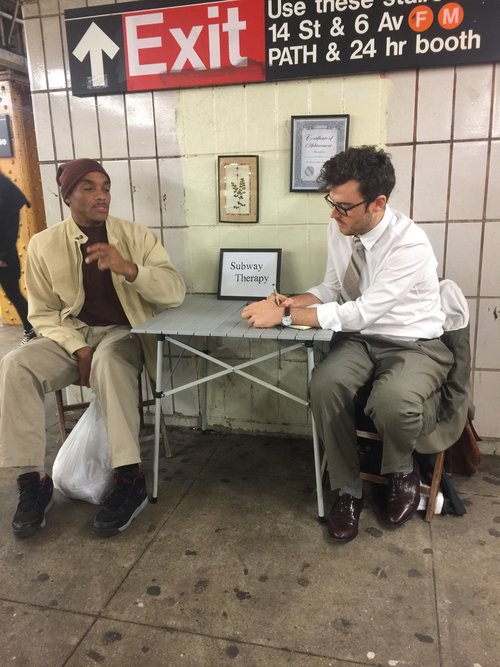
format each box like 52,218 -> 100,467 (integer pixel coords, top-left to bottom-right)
52,398 -> 113,505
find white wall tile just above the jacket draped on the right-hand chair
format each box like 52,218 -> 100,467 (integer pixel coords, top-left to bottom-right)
445,222 -> 482,296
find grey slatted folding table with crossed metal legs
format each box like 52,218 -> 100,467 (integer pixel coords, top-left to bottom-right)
132,295 -> 333,519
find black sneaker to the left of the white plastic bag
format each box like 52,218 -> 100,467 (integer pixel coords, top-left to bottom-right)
12,472 -> 54,537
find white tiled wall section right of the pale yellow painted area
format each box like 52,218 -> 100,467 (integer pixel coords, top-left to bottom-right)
387,65 -> 500,438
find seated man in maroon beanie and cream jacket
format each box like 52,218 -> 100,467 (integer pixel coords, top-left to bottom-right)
0,158 -> 185,537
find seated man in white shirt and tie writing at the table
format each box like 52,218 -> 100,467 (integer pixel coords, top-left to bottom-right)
243,146 -> 453,542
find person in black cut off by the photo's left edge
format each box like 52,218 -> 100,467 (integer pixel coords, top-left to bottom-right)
0,172 -> 36,345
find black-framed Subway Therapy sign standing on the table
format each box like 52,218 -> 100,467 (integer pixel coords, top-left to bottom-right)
217,248 -> 281,301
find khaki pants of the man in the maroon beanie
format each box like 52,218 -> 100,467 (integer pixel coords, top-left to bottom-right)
0,323 -> 142,470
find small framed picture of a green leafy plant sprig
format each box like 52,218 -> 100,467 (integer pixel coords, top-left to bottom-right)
218,155 -> 259,222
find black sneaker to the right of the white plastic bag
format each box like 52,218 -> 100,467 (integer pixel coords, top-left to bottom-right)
92,473 -> 148,537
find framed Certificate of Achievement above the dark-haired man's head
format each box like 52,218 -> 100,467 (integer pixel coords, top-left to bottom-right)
290,116 -> 349,192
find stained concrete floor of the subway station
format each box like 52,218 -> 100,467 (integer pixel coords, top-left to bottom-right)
0,326 -> 500,667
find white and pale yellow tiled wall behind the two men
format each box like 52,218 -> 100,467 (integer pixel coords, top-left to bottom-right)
23,0 -> 500,438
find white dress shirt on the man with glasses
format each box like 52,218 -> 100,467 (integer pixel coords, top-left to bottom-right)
308,206 -> 445,340
